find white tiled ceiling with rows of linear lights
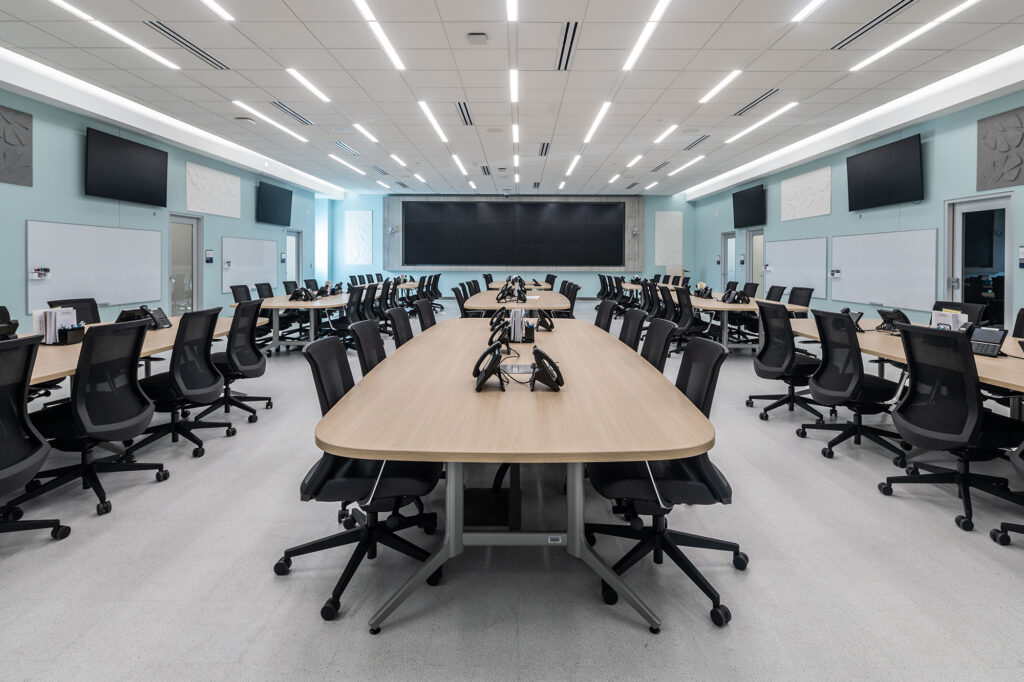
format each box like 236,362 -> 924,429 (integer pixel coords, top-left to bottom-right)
0,0 -> 1024,195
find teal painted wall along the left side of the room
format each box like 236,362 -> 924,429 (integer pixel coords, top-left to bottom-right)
0,90 -> 315,329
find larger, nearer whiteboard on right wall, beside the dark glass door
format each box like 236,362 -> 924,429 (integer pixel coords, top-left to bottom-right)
833,229 -> 938,310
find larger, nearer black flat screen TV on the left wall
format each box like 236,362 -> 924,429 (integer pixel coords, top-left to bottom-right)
85,128 -> 167,206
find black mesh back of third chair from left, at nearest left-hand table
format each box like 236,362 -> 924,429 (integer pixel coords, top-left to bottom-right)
168,307 -> 224,404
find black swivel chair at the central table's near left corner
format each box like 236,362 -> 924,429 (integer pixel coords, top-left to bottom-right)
273,337 -> 441,621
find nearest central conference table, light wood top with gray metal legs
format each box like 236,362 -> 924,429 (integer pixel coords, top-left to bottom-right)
315,318 -> 715,634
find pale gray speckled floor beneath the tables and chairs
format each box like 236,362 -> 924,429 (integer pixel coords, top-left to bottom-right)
0,301 -> 1024,680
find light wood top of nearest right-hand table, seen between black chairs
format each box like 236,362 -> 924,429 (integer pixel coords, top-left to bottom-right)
791,317 -> 1024,391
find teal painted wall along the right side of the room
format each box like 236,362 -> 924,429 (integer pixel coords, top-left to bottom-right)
693,90 -> 1024,321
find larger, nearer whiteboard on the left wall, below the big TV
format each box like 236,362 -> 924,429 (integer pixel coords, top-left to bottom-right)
26,220 -> 164,312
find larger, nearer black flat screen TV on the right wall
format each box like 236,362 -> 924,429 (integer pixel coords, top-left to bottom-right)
846,135 -> 925,206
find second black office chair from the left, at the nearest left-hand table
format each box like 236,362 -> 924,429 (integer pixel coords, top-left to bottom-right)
15,321 -> 170,515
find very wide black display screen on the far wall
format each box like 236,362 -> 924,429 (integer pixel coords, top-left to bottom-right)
402,202 -> 626,267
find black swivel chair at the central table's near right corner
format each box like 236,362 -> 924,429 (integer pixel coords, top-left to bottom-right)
585,339 -> 750,627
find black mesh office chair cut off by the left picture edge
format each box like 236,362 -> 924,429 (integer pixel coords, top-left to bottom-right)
0,335 -> 71,540
